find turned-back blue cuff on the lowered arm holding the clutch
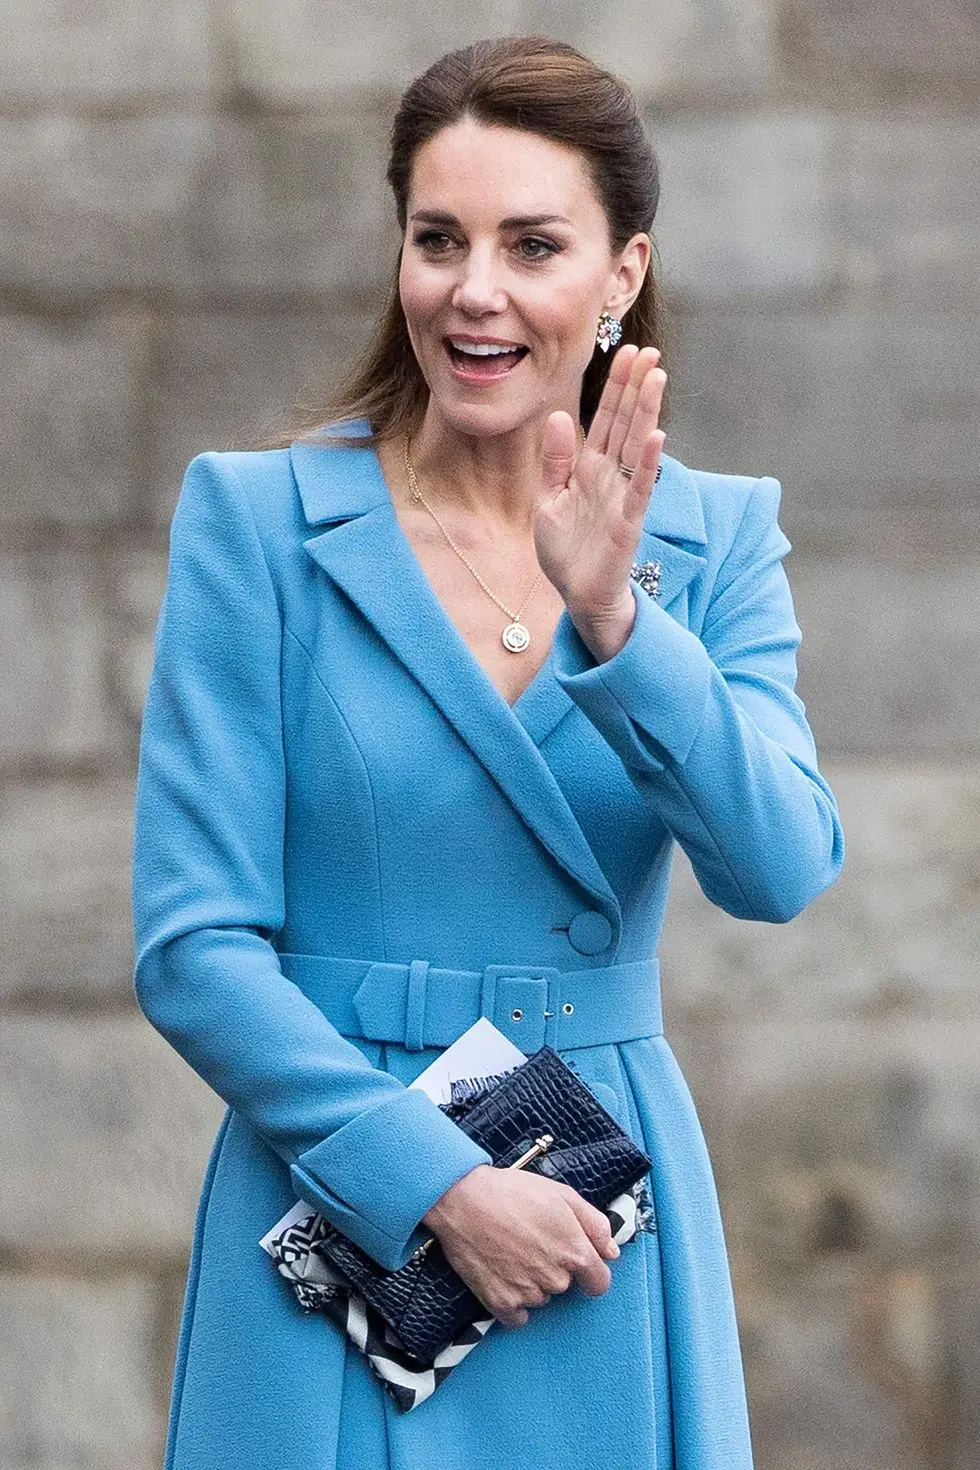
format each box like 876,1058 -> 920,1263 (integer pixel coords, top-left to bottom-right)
289,1088 -> 494,1270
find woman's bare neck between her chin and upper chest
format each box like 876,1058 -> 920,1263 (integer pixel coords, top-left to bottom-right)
411,401 -> 570,535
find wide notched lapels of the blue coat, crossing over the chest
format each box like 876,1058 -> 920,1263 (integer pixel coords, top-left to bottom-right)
289,429 -> 704,936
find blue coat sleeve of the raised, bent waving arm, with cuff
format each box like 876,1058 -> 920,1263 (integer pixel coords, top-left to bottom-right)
555,476 -> 843,923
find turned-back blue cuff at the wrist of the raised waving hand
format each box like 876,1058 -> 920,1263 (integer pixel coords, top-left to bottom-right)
552,582 -> 711,770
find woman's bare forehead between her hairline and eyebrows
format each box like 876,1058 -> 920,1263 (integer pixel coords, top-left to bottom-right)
408,118 -> 605,228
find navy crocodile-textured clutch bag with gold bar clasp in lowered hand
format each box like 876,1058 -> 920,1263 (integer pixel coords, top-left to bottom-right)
317,1047 -> 652,1361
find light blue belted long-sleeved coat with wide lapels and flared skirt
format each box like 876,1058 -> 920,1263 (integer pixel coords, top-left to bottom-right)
134,429 -> 842,1470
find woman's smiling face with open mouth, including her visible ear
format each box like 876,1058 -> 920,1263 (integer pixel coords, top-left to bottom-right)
398,118 -> 649,435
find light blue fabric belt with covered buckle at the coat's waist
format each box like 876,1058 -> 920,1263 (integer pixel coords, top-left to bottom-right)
279,953 -> 664,1055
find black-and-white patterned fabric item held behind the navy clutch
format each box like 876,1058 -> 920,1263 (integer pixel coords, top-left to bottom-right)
262,1078 -> 657,1413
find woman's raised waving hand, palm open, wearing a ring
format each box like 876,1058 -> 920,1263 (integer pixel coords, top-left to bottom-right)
533,345 -> 667,659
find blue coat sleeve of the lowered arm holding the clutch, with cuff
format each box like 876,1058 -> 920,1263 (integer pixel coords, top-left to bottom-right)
132,453 -> 492,1270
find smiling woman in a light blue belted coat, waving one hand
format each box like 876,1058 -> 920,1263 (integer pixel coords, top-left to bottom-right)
134,31 -> 842,1470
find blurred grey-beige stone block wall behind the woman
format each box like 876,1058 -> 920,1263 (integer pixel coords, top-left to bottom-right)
0,0 -> 980,1470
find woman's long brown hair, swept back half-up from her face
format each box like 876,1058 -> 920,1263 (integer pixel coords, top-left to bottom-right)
259,37 -> 666,448
